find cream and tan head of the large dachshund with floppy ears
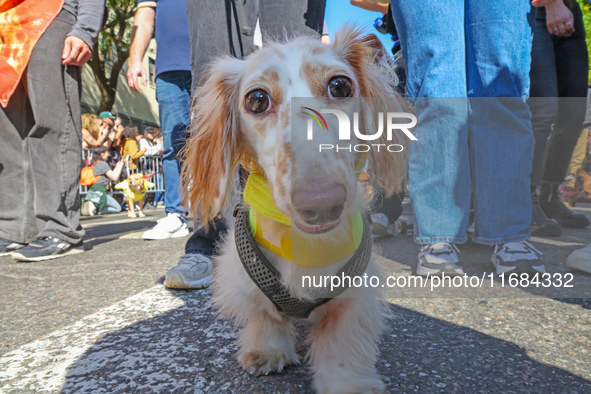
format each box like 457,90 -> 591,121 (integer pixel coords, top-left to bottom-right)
183,29 -> 406,234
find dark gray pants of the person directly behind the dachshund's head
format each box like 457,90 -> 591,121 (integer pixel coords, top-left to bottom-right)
185,0 -> 326,255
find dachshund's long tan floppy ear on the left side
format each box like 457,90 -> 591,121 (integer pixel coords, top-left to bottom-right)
181,58 -> 244,225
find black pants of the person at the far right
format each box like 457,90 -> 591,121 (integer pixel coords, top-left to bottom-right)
528,2 -> 589,186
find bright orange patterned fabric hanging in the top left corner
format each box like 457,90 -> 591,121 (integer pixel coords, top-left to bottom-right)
0,0 -> 65,108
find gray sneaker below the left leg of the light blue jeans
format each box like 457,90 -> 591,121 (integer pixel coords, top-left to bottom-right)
417,242 -> 464,276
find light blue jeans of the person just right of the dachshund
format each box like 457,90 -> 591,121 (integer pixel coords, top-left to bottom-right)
391,0 -> 534,245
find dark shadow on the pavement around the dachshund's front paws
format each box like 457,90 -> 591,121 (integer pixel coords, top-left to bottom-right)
63,292 -> 591,393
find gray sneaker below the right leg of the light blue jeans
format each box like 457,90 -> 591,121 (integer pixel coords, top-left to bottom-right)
491,241 -> 546,275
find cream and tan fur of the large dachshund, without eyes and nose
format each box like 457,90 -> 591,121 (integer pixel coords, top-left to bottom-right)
183,27 -> 407,394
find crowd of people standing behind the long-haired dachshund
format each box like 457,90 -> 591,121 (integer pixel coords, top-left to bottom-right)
0,0 -> 591,280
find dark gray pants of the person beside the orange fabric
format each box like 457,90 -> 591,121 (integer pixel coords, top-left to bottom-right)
0,10 -> 84,244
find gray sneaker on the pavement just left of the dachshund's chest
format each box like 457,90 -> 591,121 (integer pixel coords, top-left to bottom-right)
164,253 -> 213,289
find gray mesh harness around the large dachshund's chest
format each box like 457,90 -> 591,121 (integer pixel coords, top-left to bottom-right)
234,206 -> 371,318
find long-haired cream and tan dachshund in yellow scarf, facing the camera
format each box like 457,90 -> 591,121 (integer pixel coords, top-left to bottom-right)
183,27 -> 409,394
